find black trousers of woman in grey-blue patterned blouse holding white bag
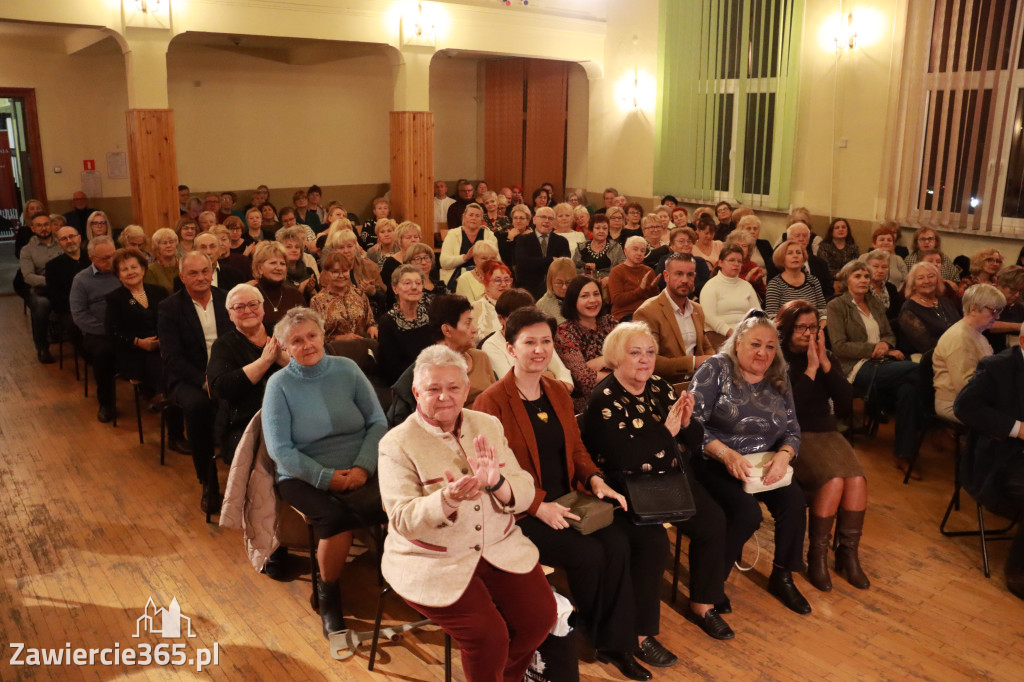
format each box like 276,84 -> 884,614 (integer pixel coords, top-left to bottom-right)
693,458 -> 807,578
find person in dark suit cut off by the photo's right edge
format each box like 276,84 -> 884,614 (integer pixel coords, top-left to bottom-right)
953,334 -> 1024,599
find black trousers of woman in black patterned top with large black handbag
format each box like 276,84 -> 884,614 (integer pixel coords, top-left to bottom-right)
675,467 -> 728,604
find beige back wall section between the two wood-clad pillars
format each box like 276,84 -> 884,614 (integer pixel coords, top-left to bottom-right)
167,43 -> 393,190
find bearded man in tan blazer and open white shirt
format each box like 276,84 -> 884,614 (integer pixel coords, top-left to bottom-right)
633,253 -> 715,383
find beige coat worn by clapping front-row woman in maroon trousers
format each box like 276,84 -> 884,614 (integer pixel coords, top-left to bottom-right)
377,410 -> 540,606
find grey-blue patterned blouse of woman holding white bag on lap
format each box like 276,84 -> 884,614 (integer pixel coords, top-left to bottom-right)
690,353 -> 800,457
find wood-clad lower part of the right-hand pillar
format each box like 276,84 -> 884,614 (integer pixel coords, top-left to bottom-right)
390,112 -> 434,238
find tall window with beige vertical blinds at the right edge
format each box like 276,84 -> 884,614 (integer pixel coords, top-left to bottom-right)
887,0 -> 1024,236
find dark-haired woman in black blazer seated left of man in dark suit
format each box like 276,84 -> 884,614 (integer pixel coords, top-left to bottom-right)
106,247 -> 167,397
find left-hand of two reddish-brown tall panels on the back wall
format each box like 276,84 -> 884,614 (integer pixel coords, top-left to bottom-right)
483,59 -> 525,189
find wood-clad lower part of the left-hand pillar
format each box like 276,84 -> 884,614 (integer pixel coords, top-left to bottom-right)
125,109 -> 178,235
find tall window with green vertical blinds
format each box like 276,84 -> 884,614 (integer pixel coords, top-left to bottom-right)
654,0 -> 803,208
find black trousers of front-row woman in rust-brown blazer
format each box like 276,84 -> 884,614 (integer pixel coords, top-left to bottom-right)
518,511 -> 669,651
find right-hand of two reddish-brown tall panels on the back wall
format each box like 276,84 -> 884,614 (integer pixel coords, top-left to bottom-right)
523,59 -> 569,197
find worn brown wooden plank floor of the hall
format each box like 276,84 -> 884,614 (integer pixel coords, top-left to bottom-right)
0,298 -> 1024,681
